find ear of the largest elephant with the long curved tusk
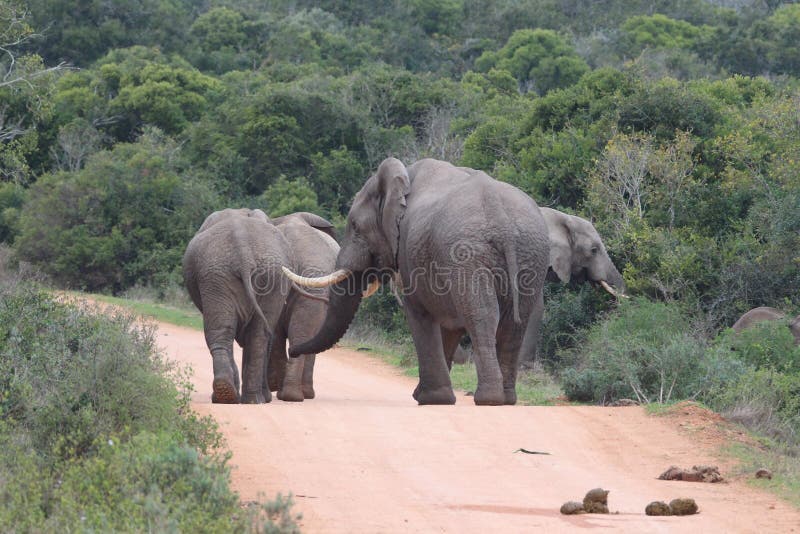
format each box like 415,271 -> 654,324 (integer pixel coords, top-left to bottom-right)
376,158 -> 411,267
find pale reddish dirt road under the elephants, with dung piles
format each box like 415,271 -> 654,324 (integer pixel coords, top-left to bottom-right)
159,325 -> 800,533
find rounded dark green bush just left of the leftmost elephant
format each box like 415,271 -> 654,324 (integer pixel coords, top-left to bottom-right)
16,129 -> 219,291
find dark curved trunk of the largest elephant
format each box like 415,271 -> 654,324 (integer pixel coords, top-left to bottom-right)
289,272 -> 365,358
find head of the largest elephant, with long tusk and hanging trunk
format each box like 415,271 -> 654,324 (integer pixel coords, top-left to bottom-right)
284,158 -> 411,356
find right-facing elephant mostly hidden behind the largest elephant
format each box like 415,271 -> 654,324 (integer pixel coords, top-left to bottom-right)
520,208 -> 625,365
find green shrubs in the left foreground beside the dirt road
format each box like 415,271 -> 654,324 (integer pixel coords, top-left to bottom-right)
0,285 -> 296,532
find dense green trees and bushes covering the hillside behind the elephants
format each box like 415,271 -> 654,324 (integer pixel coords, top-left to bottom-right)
0,0 -> 800,442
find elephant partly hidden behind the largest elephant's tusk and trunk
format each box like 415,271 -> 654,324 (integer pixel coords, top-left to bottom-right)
267,212 -> 339,402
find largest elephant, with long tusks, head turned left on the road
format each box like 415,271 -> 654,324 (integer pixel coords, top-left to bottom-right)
284,158 -> 549,405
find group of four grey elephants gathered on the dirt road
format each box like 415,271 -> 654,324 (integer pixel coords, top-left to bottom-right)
183,158 -> 624,405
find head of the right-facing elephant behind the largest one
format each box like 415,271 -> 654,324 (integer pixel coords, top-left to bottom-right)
540,208 -> 625,296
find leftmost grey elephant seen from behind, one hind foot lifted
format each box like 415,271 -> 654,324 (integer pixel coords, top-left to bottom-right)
183,209 -> 291,404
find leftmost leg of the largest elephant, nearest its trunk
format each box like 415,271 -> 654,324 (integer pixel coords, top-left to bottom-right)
404,306 -> 456,404
